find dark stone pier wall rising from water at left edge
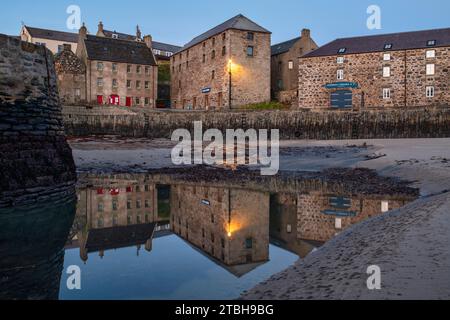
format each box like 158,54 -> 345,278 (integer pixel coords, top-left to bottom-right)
0,35 -> 76,206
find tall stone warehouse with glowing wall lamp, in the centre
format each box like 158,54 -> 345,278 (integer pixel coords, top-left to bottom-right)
171,15 -> 271,110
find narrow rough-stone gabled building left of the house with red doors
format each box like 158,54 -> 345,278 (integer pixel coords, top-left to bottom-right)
55,46 -> 86,105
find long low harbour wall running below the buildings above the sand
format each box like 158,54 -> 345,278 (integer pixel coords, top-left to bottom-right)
63,107 -> 450,140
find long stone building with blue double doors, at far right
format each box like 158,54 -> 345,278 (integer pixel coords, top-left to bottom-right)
299,29 -> 450,109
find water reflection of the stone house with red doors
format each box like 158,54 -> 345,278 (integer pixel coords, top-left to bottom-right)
72,179 -> 165,261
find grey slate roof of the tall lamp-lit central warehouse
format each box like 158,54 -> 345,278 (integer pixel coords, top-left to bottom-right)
178,14 -> 271,52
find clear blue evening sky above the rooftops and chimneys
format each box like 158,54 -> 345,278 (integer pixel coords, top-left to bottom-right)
0,0 -> 450,45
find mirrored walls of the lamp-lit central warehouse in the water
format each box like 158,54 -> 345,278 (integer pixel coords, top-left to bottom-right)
171,184 -> 269,266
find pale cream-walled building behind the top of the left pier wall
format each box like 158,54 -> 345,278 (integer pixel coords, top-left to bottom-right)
20,25 -> 78,54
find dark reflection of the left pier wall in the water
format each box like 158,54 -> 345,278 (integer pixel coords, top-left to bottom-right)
0,196 -> 76,300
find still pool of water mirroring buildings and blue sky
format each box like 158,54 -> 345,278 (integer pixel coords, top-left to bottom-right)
0,168 -> 417,300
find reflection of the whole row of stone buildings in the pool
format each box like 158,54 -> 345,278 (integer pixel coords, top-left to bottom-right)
68,170 -> 417,277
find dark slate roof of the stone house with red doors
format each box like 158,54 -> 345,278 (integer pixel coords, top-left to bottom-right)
84,35 -> 156,66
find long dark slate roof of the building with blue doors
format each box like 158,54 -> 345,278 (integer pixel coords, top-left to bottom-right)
303,28 -> 450,58
